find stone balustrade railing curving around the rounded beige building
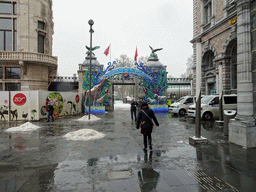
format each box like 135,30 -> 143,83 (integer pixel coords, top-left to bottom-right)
0,51 -> 58,65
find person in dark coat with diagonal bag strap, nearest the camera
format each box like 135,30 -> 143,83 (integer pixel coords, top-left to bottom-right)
136,101 -> 159,151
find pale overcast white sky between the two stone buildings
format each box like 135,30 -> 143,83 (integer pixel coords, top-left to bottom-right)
53,0 -> 193,77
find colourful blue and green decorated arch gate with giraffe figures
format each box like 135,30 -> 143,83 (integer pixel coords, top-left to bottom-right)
83,62 -> 168,114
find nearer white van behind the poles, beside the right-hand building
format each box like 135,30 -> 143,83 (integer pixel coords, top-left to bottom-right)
188,94 -> 237,120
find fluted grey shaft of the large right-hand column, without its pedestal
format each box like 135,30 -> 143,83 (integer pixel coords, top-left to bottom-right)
237,0 -> 253,120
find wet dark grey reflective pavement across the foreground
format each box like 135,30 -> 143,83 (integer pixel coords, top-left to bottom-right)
0,110 -> 256,192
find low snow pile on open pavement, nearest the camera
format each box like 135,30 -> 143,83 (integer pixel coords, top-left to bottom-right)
63,129 -> 105,141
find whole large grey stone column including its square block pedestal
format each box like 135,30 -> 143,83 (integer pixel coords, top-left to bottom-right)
229,0 -> 256,148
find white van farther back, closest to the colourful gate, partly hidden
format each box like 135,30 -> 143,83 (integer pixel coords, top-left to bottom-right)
169,95 -> 195,115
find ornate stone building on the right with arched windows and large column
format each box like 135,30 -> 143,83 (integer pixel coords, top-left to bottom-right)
191,0 -> 256,147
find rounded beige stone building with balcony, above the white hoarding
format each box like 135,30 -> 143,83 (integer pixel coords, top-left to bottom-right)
0,0 -> 57,91
